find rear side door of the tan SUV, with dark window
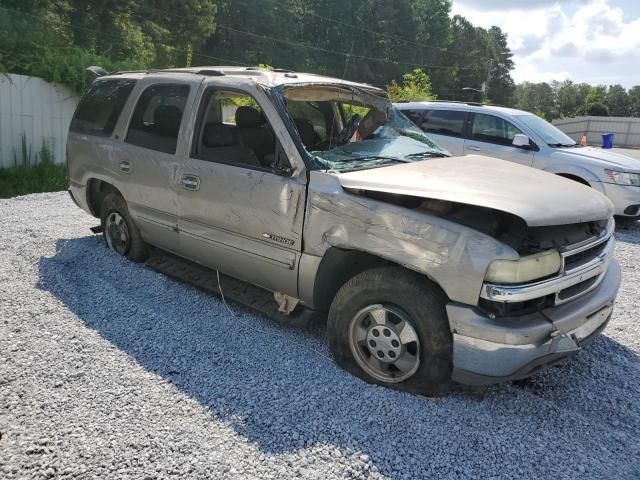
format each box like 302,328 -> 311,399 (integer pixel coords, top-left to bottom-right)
113,78 -> 197,251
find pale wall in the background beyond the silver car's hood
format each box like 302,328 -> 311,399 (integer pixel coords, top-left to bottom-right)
553,116 -> 640,147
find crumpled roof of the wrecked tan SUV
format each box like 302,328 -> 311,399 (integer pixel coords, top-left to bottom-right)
101,66 -> 386,96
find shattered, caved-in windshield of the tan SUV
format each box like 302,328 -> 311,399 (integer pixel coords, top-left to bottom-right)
282,84 -> 449,171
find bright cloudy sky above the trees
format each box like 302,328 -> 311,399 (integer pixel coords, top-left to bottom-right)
452,0 -> 640,88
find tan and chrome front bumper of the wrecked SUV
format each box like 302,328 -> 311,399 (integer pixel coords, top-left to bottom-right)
447,259 -> 620,385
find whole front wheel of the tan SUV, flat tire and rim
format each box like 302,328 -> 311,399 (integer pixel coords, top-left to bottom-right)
327,267 -> 453,395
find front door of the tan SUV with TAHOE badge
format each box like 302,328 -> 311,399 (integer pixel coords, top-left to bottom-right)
179,86 -> 306,297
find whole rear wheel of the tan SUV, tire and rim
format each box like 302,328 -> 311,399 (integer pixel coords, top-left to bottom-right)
100,193 -> 149,262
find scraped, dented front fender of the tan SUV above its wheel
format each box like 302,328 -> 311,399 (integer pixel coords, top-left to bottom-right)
304,172 -> 518,305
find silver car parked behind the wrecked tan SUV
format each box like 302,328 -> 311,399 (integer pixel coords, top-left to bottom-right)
396,102 -> 640,221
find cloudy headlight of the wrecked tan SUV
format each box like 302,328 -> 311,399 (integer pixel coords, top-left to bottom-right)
485,250 -> 561,283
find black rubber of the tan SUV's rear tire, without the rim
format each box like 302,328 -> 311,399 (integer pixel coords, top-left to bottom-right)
100,193 -> 149,263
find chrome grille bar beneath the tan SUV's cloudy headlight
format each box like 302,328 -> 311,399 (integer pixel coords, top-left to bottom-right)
480,237 -> 615,305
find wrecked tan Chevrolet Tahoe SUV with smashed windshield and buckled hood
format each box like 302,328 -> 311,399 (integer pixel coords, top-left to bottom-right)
67,67 -> 620,394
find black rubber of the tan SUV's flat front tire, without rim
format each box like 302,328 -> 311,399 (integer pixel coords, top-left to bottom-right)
327,267 -> 453,396
